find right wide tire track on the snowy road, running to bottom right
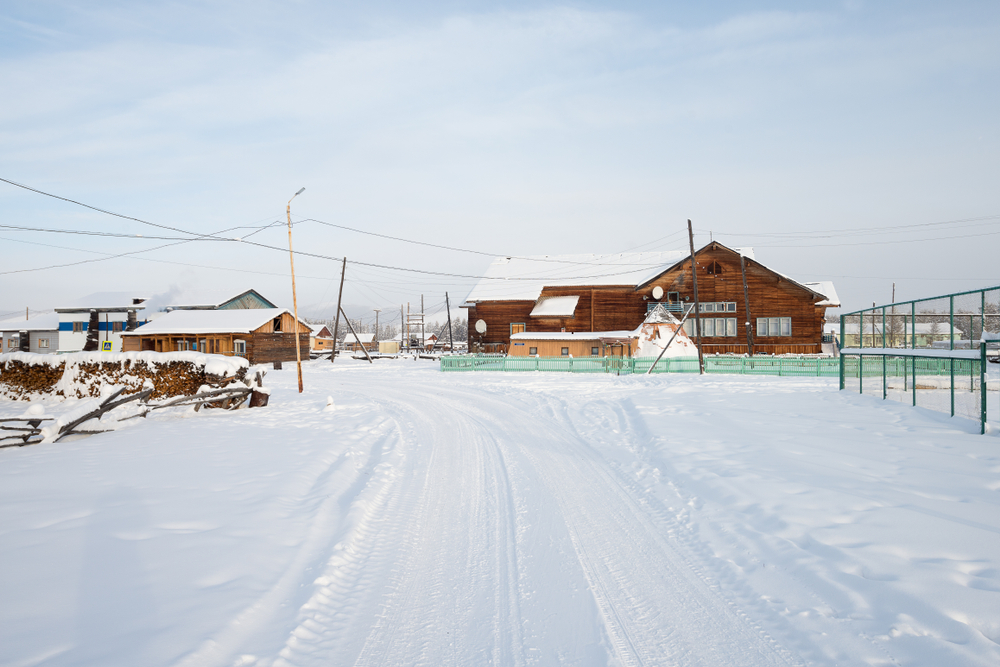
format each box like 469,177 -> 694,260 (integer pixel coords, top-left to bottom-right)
428,386 -> 795,666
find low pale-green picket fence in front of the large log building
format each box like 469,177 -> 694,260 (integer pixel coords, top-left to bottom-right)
441,355 -> 840,377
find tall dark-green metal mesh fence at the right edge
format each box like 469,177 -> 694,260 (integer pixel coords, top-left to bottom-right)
839,286 -> 1000,433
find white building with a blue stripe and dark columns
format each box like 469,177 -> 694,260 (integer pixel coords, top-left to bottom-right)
50,293 -> 146,352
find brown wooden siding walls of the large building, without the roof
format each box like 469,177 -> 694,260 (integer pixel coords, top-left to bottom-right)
469,244 -> 826,354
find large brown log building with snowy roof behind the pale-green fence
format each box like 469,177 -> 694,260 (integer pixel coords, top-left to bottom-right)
463,242 -> 840,354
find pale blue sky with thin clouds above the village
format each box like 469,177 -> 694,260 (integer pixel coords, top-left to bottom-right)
0,0 -> 1000,330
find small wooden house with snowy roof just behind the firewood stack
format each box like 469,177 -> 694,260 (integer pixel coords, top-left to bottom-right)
122,308 -> 310,364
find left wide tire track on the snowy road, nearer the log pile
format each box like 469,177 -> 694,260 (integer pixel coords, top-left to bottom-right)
355,390 -> 524,666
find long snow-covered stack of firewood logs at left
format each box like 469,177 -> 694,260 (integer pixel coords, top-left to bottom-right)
0,352 -> 250,400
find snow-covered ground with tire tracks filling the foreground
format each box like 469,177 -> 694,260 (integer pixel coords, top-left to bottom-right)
0,360 -> 1000,667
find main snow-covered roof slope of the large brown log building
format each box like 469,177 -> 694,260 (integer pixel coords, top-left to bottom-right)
465,248 -> 753,303
